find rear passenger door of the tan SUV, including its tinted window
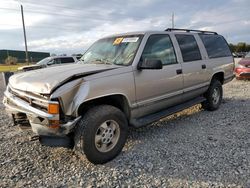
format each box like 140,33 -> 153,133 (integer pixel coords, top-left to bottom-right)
175,34 -> 208,101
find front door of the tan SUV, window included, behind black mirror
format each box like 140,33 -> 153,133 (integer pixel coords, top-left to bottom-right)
134,34 -> 183,116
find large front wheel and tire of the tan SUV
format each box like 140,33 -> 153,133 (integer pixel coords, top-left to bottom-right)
74,105 -> 128,164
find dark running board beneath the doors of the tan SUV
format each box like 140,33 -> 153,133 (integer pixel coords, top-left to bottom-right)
130,97 -> 206,128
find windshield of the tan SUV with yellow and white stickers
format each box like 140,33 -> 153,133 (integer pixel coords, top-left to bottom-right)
80,35 -> 142,66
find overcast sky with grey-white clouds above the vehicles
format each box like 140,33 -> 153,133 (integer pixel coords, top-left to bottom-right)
0,0 -> 250,55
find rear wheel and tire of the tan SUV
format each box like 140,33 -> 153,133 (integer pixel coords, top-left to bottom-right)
201,79 -> 223,111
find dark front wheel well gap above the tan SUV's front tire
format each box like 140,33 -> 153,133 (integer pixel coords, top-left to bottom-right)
77,94 -> 130,119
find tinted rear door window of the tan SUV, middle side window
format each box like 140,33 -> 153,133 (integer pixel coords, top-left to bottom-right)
175,34 -> 201,62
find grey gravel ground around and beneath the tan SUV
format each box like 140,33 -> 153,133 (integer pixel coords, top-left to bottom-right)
0,78 -> 250,187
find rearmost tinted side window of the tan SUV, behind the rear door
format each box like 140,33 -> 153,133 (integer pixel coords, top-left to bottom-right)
199,34 -> 232,58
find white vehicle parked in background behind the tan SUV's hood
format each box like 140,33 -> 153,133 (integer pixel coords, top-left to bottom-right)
18,56 -> 78,71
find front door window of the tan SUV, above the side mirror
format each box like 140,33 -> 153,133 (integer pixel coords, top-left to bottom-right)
142,35 -> 177,65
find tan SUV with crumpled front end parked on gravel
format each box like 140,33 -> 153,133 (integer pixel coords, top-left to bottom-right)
3,29 -> 234,164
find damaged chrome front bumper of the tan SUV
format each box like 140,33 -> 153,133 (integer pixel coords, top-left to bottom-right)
3,89 -> 81,136
